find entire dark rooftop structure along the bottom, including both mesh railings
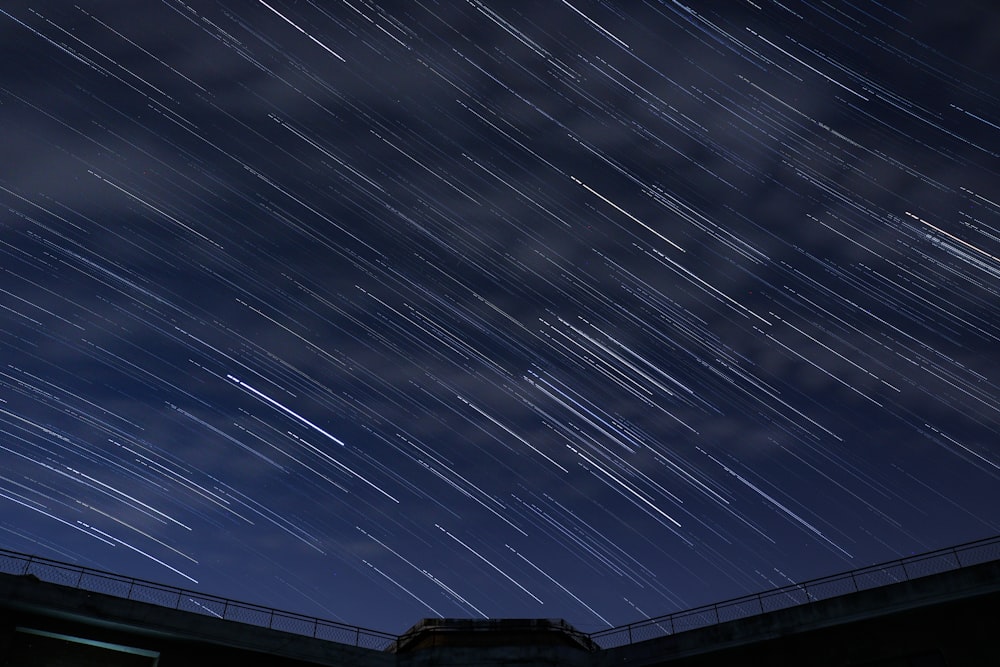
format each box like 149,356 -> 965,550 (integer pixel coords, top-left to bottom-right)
0,538 -> 1000,667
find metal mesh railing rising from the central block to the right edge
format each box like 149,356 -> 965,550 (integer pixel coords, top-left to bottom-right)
590,536 -> 1000,649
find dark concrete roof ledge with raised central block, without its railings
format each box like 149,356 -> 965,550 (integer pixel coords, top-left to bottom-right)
0,561 -> 1000,667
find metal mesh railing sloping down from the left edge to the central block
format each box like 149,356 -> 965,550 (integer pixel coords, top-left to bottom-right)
0,549 -> 397,651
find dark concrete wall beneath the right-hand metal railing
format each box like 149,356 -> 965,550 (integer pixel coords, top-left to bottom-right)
593,562 -> 1000,667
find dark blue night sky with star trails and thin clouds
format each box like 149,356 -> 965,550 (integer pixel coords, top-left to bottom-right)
0,0 -> 1000,632
